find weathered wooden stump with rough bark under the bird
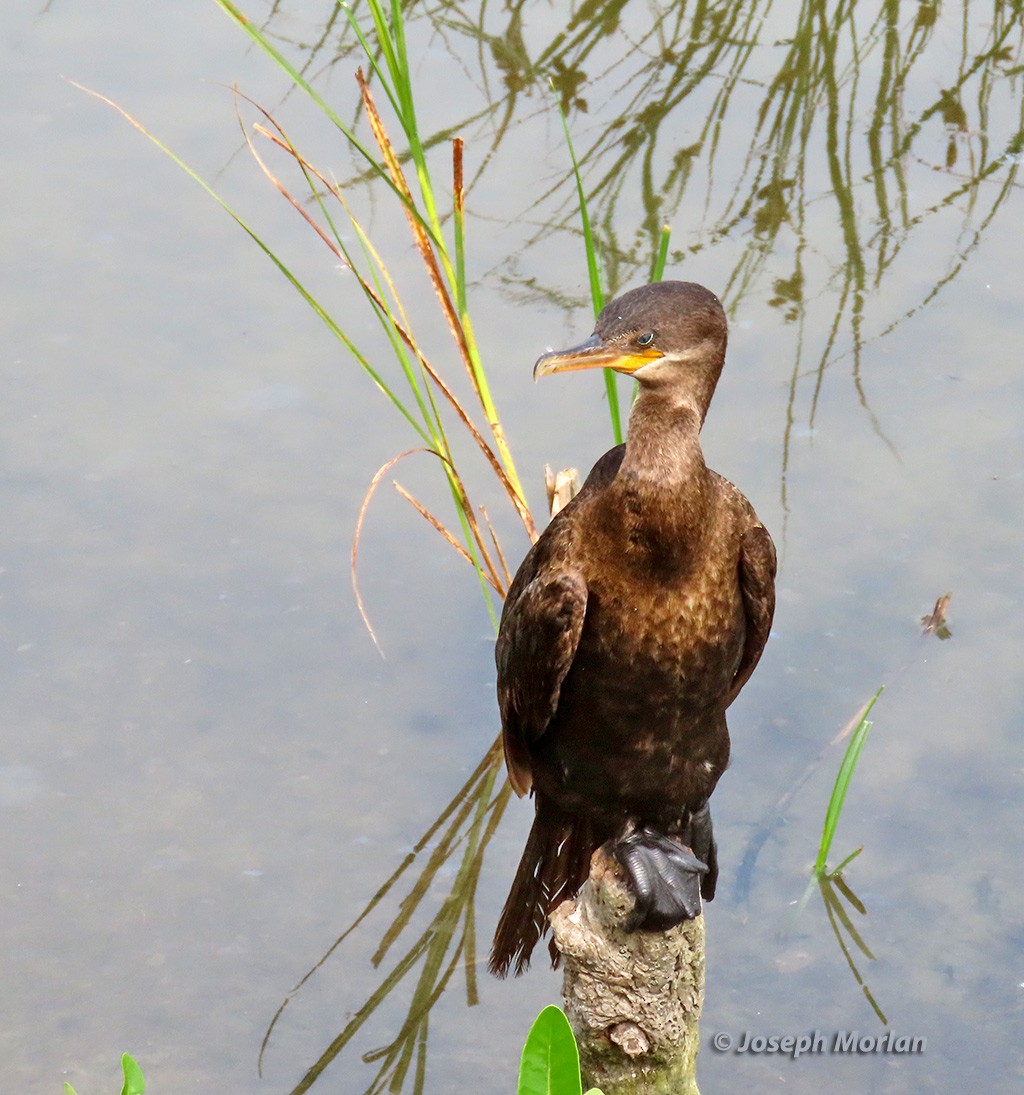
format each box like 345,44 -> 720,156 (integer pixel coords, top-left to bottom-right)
550,848 -> 704,1095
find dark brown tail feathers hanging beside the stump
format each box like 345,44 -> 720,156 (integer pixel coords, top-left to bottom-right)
490,792 -> 602,977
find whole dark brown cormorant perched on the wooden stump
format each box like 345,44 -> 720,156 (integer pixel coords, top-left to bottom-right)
491,281 -> 775,976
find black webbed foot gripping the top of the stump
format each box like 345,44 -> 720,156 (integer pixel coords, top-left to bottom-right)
613,823 -> 714,932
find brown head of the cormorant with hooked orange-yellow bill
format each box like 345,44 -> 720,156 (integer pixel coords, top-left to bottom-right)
533,281 -> 728,420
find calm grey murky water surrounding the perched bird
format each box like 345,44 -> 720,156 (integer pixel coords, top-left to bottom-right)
0,2 -> 1024,1095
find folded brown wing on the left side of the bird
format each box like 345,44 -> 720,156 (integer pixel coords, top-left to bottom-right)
494,561 -> 587,795
